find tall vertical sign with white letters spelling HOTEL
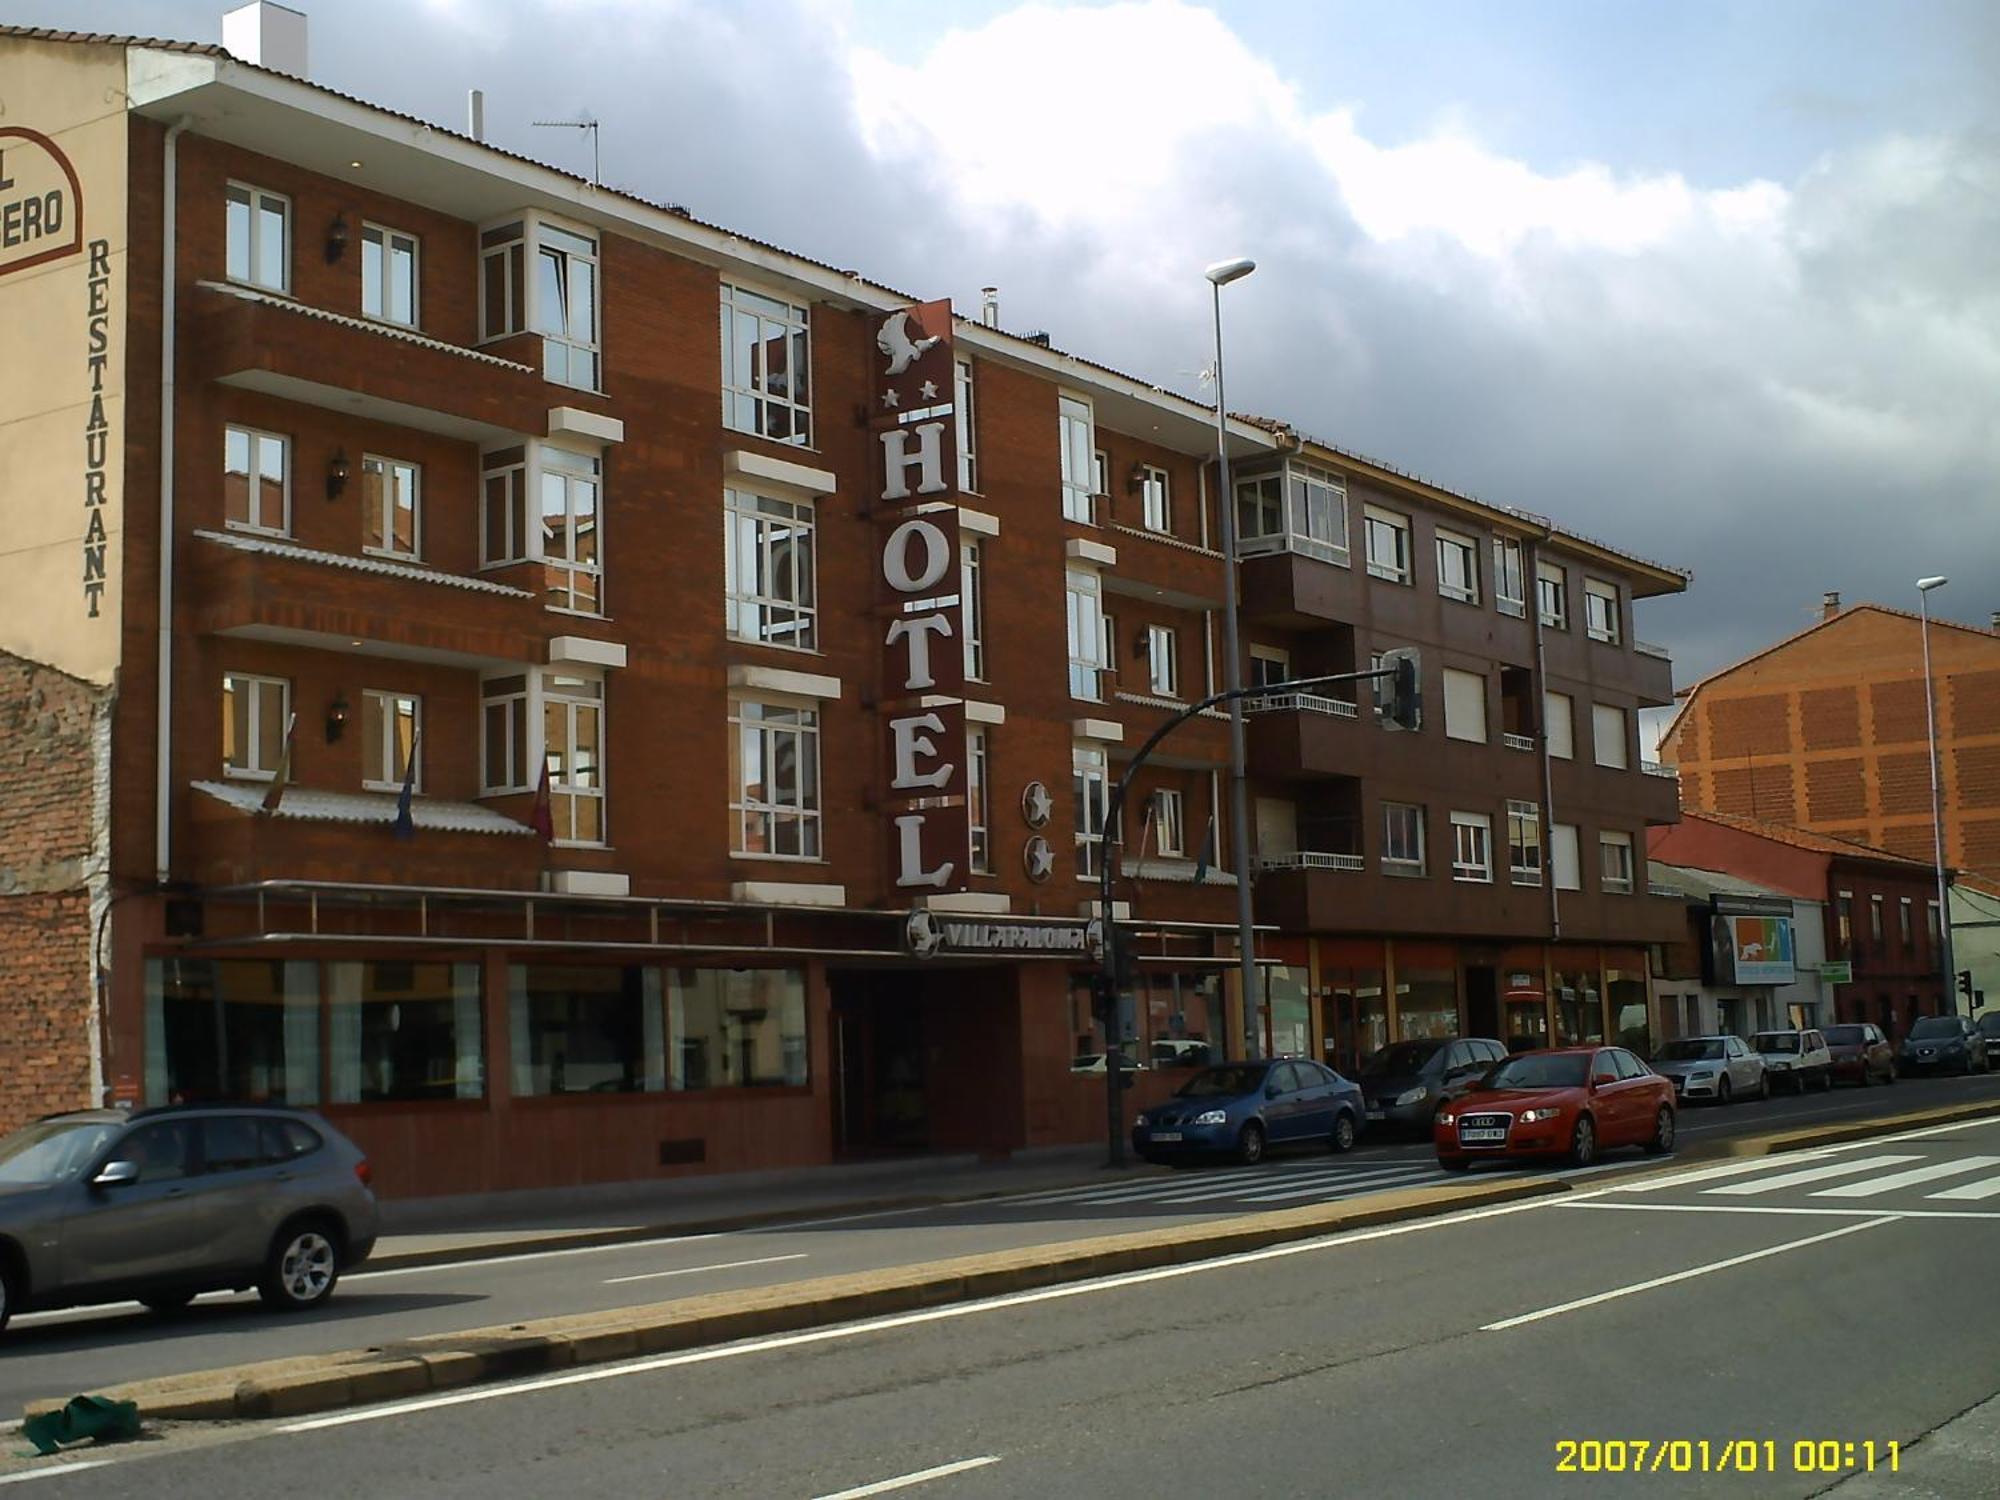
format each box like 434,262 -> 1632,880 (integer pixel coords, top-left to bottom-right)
870,302 -> 972,896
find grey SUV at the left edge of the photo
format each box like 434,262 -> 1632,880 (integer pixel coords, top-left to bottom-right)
0,1106 -> 376,1328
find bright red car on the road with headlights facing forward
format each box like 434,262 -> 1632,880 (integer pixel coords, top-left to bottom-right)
1432,1046 -> 1676,1172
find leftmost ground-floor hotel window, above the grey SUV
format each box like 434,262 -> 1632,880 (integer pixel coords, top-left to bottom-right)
146,958 -> 320,1104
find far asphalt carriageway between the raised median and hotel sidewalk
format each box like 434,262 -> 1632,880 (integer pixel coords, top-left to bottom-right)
0,1078 -> 2000,1412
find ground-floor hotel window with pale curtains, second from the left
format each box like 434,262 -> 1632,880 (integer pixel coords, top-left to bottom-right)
326,958 -> 486,1104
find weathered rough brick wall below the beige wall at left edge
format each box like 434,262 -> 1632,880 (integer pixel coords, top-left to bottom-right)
0,654 -> 106,1130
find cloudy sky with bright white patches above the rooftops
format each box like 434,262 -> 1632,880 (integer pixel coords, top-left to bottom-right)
27,0 -> 2000,682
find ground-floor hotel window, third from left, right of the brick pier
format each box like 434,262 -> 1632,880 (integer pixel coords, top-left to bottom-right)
508,964 -> 666,1096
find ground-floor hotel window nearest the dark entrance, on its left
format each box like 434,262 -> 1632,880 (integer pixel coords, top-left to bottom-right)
666,968 -> 808,1088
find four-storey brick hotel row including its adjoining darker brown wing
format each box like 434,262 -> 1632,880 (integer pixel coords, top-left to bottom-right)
0,6 -> 1686,1196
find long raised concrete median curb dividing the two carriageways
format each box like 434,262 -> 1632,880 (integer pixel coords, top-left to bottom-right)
26,1178 -> 1568,1422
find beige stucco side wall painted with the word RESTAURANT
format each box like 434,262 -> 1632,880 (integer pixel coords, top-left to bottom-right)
0,38 -> 128,682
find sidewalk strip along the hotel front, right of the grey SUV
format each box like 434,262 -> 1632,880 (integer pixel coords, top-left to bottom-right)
368,1146 -> 1162,1270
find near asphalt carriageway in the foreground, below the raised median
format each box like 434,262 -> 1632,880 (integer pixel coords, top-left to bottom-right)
15,1122 -> 2000,1500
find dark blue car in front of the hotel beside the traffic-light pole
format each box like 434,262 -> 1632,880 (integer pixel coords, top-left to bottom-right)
1132,1058 -> 1366,1164
